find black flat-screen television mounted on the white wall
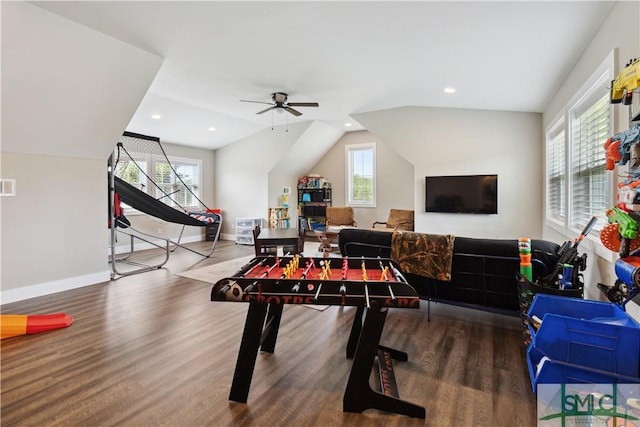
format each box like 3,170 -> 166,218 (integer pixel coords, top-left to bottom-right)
425,175 -> 498,214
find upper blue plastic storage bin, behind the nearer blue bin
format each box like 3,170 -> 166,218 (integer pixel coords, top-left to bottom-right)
527,294 -> 640,338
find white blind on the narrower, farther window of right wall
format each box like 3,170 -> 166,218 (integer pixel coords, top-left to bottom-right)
547,118 -> 566,224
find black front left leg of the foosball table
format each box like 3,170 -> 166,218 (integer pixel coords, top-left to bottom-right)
229,301 -> 267,403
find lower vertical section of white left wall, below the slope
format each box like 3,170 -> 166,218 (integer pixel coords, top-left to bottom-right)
0,152 -> 109,303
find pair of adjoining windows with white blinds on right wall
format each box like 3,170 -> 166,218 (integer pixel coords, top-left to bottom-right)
545,52 -> 614,237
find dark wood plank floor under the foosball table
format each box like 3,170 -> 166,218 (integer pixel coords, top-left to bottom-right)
0,241 -> 536,427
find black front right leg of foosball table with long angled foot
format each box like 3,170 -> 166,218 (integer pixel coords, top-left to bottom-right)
342,308 -> 426,418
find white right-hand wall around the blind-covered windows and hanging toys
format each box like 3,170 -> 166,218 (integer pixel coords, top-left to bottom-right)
543,1 -> 640,319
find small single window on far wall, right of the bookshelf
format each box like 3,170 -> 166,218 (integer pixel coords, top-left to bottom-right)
345,143 -> 376,207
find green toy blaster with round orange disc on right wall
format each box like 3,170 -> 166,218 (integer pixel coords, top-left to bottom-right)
600,207 -> 640,258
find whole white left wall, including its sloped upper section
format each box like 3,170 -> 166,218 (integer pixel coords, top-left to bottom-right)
0,2 -> 162,303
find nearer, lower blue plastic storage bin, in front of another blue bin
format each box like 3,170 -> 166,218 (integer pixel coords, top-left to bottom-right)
527,314 -> 640,392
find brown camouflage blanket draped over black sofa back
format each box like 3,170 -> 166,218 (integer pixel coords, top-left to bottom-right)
391,230 -> 455,282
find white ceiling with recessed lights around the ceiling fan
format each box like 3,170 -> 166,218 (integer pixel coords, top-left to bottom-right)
31,1 -> 614,149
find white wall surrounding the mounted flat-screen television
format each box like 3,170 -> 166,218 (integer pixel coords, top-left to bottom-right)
354,107 -> 542,239
